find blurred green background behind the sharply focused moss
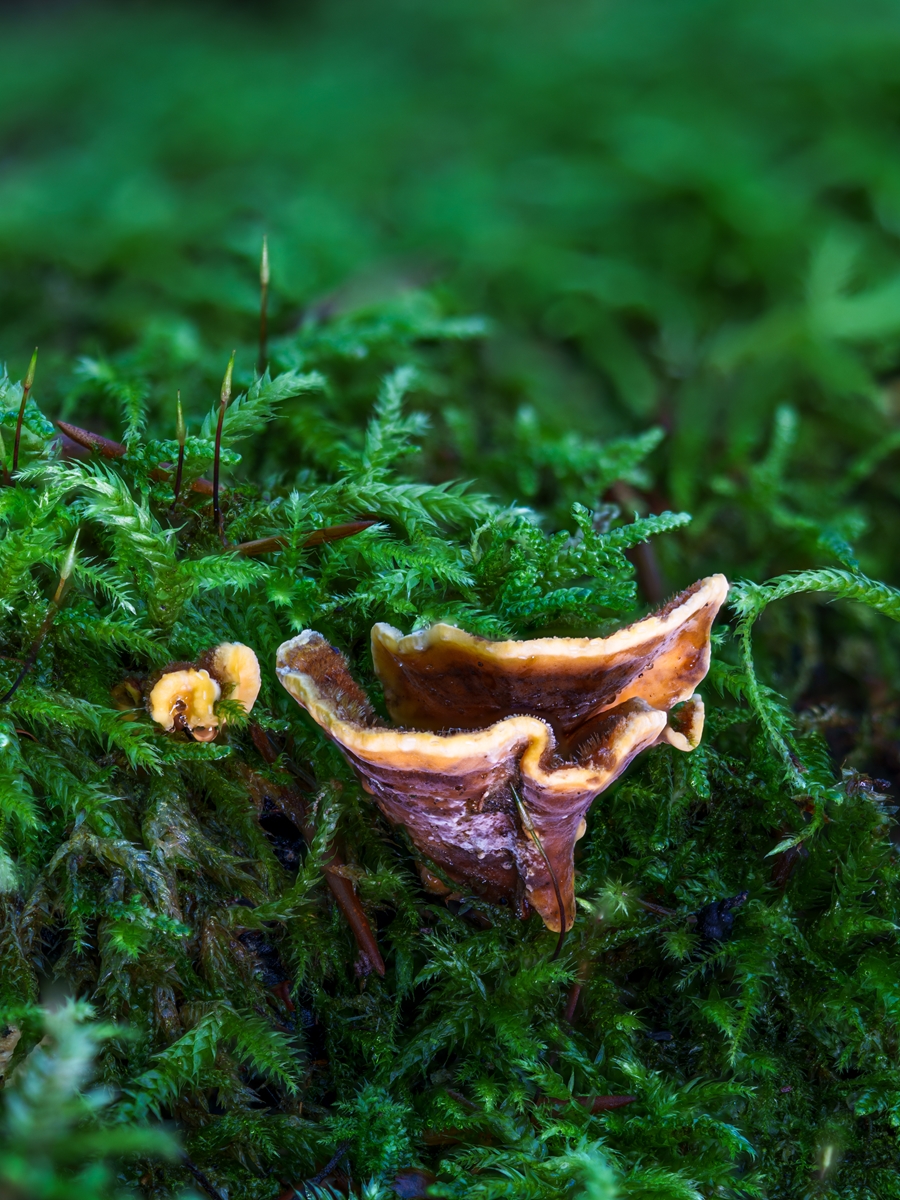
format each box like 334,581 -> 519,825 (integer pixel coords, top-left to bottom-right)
0,0 -> 900,582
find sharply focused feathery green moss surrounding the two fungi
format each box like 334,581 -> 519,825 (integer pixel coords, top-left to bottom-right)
0,302 -> 900,1196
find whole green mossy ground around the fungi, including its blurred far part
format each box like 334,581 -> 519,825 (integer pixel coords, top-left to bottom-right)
0,0 -> 900,1200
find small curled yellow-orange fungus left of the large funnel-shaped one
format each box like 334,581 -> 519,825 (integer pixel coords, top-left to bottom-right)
146,642 -> 260,742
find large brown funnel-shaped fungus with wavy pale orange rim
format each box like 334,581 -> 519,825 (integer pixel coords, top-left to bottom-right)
276,575 -> 727,931
